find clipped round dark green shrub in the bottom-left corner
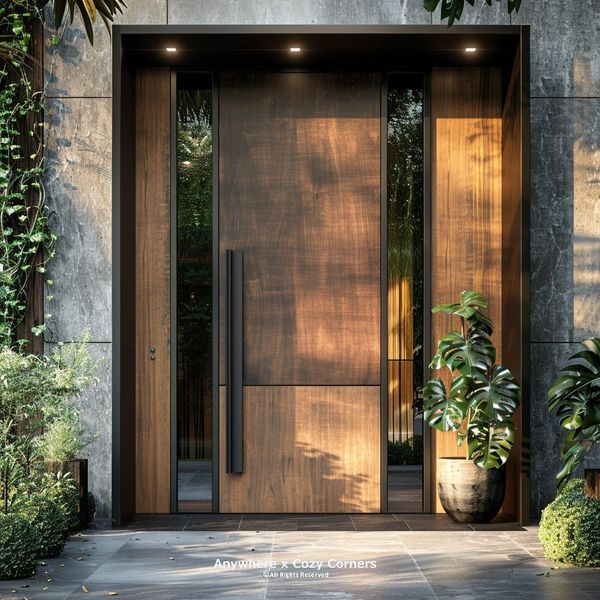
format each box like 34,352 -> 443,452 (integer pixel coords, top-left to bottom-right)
0,513 -> 39,579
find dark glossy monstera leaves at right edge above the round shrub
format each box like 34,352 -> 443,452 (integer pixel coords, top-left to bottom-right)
548,338 -> 600,490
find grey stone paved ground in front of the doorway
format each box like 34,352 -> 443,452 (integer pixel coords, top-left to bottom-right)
0,515 -> 600,600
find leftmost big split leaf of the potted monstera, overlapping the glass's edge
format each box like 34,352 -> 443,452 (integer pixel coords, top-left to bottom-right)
423,377 -> 469,431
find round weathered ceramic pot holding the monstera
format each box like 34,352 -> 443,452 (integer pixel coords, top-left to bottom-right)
437,458 -> 506,523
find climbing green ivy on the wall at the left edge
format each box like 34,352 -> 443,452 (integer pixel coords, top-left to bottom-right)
0,0 -> 56,347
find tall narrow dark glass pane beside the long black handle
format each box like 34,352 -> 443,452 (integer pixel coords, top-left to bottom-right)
175,74 -> 213,512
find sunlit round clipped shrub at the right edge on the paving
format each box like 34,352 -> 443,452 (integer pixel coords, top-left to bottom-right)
540,479 -> 600,567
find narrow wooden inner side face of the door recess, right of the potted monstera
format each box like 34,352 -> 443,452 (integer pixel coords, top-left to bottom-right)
502,53 -> 529,519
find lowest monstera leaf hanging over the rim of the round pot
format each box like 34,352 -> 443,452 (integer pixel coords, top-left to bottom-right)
467,419 -> 515,469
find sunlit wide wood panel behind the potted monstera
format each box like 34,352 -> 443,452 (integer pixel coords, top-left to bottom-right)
431,67 -> 504,512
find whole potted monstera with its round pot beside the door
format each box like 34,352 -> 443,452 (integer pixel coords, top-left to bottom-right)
423,291 -> 521,523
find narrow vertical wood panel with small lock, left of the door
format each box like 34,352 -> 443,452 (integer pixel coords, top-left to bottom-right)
135,68 -> 171,513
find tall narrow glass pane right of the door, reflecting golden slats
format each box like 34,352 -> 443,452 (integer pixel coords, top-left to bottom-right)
387,74 -> 423,512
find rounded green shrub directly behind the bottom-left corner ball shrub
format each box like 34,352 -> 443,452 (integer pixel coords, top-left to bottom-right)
16,494 -> 69,556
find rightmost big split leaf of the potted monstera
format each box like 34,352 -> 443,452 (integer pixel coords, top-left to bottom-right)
467,365 -> 521,422
